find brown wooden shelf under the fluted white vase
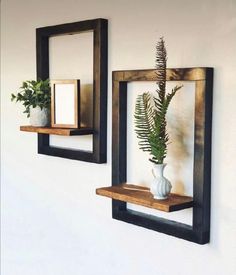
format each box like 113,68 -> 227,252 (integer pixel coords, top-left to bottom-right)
96,184 -> 193,212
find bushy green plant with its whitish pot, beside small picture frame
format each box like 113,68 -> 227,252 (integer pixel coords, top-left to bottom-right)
11,79 -> 51,127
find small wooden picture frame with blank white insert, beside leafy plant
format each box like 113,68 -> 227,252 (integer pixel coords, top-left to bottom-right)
50,79 -> 80,128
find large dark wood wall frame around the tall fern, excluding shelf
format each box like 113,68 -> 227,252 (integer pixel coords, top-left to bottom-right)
112,68 -> 213,244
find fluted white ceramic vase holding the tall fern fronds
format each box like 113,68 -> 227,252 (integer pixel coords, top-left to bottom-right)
150,163 -> 172,200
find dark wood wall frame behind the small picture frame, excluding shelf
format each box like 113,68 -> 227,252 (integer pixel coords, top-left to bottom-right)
36,18 -> 108,163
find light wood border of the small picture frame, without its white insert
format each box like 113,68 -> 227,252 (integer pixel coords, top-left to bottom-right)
50,79 -> 80,128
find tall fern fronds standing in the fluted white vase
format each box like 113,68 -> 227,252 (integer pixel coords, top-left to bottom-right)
134,37 -> 182,164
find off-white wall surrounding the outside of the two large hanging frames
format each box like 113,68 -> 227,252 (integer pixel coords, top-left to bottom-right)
1,0 -> 236,275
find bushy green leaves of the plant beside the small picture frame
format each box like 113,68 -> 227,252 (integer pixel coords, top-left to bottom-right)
11,79 -> 51,117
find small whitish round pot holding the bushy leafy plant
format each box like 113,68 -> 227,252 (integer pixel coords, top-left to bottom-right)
30,106 -> 49,127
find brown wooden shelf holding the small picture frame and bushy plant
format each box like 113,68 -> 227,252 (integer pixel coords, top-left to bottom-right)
20,126 -> 94,136
